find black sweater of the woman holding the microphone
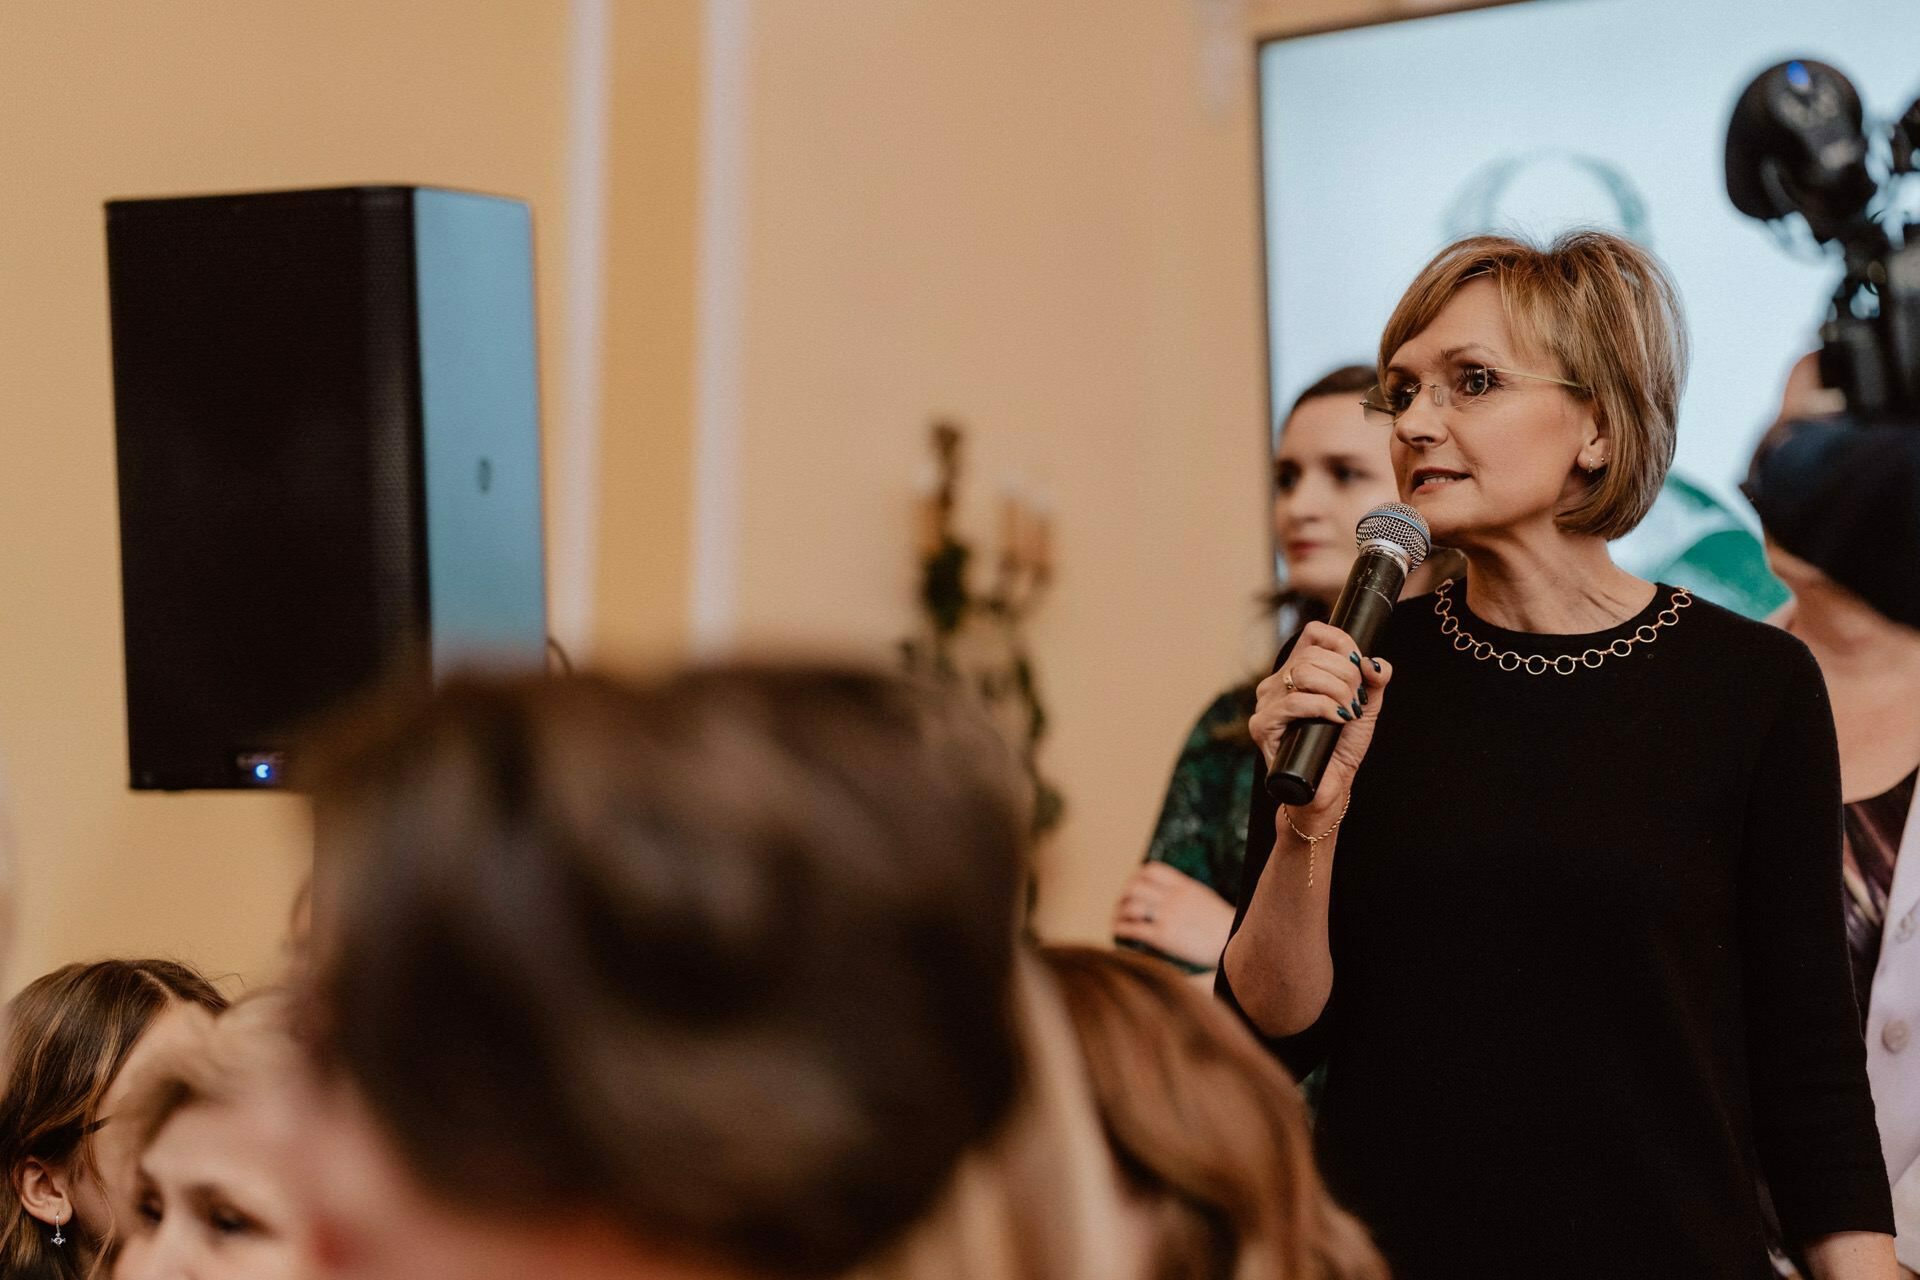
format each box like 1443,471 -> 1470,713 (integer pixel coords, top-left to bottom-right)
1219,585 -> 1893,1280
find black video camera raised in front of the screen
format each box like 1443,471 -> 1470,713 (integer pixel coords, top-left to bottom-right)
1726,58 -> 1920,424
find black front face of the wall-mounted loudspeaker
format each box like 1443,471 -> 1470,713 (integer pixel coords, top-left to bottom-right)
108,188 -> 426,789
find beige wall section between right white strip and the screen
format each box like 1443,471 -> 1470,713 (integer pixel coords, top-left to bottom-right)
737,0 -> 1265,938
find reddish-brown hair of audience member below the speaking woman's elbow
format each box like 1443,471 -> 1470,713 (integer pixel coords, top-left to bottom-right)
1043,946 -> 1386,1280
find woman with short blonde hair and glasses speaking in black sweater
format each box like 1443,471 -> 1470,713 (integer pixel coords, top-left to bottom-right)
1221,232 -> 1895,1280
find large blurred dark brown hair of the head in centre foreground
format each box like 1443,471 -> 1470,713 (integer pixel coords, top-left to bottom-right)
305,664 -> 1025,1274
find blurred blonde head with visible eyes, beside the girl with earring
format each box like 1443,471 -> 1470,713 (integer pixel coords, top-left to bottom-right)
113,992 -> 307,1280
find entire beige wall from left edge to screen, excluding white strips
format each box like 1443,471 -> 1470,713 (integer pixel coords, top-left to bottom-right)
0,0 -> 1489,983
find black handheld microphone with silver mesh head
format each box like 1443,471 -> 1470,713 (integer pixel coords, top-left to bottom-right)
1267,503 -> 1432,804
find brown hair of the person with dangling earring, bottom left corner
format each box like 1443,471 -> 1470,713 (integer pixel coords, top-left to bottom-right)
0,960 -> 227,1280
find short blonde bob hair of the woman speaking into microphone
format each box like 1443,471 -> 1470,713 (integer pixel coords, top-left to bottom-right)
1380,230 -> 1688,539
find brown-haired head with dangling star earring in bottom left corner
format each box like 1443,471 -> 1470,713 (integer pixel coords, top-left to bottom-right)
0,960 -> 227,1280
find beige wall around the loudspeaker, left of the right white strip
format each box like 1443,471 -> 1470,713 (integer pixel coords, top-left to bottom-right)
0,0 -> 699,984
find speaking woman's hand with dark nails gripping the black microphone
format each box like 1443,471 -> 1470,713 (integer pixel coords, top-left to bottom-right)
1250,503 -> 1432,806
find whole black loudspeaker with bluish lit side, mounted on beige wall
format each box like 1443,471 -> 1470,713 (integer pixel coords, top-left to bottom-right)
106,186 -> 547,791
